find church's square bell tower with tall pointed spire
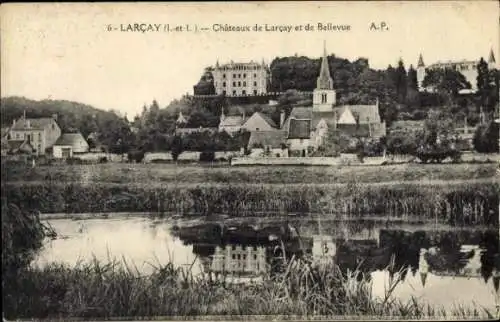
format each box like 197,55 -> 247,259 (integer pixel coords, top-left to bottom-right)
313,44 -> 336,112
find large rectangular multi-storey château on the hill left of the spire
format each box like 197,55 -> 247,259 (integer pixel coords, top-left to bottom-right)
212,61 -> 270,96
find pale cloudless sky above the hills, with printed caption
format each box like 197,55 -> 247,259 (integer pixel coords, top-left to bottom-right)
0,1 -> 500,118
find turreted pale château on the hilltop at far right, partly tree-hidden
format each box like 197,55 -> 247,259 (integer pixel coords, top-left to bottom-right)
417,49 -> 496,94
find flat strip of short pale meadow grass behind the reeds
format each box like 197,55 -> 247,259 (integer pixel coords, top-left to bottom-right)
2,163 -> 497,184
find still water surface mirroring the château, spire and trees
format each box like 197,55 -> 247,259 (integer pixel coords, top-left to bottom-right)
37,218 -> 500,309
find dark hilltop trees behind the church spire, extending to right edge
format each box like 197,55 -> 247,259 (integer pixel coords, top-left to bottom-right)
270,55 -> 500,125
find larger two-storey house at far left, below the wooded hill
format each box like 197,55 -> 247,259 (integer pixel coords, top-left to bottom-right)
9,115 -> 61,155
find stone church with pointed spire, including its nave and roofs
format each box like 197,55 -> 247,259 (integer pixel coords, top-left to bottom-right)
282,42 -> 386,156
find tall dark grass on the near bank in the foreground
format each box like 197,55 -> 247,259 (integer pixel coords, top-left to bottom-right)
4,258 -> 494,319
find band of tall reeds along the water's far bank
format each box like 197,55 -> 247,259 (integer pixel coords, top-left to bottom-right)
2,181 -> 500,225
